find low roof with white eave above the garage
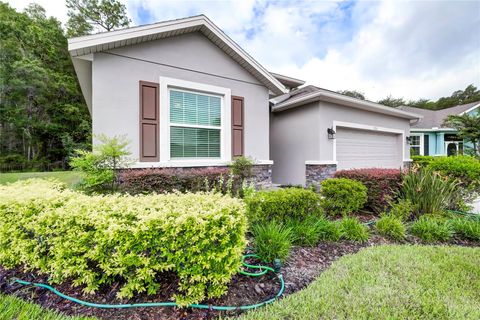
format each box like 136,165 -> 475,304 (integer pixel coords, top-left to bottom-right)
270,85 -> 422,120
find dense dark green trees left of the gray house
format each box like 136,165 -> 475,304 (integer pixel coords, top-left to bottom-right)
0,2 -> 91,163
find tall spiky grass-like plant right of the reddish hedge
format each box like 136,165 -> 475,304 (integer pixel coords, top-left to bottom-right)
400,168 -> 458,216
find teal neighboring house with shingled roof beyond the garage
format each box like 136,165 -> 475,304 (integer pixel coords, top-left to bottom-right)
399,101 -> 480,156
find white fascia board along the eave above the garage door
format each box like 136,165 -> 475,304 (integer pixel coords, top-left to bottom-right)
272,91 -> 423,120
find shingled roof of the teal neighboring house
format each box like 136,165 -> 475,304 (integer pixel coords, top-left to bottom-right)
398,101 -> 480,129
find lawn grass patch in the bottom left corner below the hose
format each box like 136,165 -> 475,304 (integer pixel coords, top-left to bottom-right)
0,294 -> 94,320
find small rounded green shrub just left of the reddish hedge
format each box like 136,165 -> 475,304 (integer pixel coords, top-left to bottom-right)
320,178 -> 367,216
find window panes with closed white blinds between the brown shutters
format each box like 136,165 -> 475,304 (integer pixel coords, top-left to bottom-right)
170,90 -> 222,159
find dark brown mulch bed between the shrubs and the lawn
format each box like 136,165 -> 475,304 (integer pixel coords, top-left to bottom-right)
0,234 -> 479,319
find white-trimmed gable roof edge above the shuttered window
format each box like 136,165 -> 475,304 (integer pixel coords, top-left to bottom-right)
68,15 -> 288,110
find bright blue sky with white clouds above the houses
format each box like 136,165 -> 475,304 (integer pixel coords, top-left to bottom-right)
7,0 -> 480,100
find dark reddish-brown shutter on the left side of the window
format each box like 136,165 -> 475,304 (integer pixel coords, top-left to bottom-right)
140,81 -> 160,162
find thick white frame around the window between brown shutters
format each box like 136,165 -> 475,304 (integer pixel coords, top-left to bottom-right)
159,77 -> 232,167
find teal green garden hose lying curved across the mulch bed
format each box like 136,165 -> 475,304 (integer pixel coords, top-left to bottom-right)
14,254 -> 285,311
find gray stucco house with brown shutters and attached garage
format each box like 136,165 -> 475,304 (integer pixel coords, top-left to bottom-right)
68,15 -> 419,188
